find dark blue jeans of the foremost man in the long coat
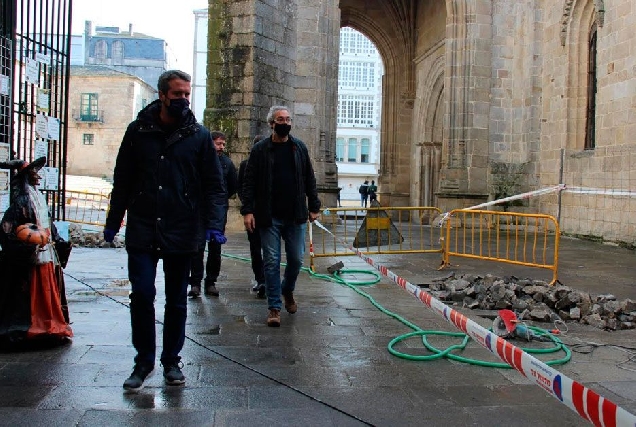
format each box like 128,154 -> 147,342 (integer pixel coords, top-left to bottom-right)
128,251 -> 192,366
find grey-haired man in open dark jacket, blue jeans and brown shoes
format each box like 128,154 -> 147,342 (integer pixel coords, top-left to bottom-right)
241,106 -> 320,327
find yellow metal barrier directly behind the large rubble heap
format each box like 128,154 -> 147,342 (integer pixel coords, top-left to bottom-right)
441,209 -> 560,284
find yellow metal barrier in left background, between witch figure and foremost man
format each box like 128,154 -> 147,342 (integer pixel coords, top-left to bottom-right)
65,190 -> 110,227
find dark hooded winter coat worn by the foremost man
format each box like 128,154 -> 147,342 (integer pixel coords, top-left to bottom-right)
106,100 -> 227,254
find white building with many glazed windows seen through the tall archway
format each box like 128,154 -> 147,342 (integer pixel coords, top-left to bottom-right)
336,27 -> 384,205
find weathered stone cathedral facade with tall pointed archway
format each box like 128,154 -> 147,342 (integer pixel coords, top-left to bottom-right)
204,0 -> 636,246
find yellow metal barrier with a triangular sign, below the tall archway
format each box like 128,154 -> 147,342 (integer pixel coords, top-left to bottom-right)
313,207 -> 442,257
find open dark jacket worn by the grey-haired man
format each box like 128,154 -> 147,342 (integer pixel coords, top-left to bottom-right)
240,135 -> 320,228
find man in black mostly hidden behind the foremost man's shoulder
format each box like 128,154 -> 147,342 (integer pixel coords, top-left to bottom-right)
188,131 -> 237,298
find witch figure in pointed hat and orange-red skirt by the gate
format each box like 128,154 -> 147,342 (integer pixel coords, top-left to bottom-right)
0,157 -> 73,350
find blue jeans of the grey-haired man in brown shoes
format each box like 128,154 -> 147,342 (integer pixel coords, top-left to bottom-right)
257,218 -> 307,310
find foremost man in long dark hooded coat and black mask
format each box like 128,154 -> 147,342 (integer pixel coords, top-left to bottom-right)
104,70 -> 227,391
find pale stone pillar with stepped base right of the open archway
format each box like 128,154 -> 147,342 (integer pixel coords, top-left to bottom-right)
438,0 -> 492,210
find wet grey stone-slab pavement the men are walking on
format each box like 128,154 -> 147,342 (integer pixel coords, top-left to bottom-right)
0,233 -> 636,426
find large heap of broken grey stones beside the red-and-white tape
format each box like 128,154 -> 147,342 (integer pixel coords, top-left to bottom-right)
420,274 -> 636,330
